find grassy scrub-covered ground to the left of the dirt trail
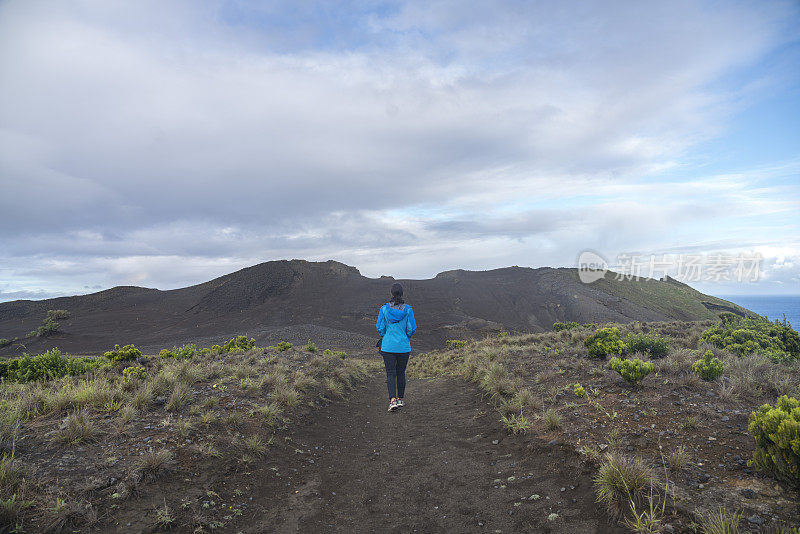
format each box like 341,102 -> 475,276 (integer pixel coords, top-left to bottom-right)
0,336 -> 368,532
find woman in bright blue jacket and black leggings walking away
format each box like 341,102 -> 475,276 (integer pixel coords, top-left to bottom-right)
375,284 -> 417,412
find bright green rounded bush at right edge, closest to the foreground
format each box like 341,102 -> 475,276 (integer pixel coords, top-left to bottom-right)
748,395 -> 800,486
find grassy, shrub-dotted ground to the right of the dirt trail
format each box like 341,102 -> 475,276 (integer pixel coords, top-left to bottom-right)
409,314 -> 800,532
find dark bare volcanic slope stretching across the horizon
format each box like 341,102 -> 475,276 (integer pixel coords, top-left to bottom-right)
0,260 -> 753,354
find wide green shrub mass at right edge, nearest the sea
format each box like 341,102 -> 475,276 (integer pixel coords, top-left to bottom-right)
701,314 -> 800,362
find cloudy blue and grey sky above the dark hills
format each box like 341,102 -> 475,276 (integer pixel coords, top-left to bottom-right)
0,0 -> 800,300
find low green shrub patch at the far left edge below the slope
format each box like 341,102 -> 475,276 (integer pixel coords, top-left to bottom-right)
0,349 -> 107,382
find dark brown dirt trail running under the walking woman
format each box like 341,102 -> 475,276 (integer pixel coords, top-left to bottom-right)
247,375 -> 623,533
